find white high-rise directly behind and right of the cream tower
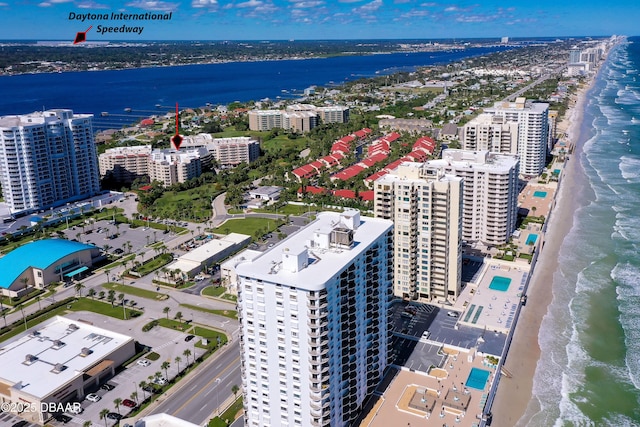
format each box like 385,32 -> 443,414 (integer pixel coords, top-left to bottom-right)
438,149 -> 519,246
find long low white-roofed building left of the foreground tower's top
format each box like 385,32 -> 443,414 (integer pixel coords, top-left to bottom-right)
168,233 -> 251,277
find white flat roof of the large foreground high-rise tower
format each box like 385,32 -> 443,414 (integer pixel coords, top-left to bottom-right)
236,210 -> 393,290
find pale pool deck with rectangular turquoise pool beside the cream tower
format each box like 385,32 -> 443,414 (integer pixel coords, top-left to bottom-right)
454,260 -> 529,333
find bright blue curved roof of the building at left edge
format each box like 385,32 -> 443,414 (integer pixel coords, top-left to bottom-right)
0,239 -> 96,289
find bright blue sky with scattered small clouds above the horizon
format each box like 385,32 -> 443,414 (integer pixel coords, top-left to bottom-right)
0,0 -> 640,41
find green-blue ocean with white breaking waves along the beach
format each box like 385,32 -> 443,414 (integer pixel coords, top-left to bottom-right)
518,38 -> 640,427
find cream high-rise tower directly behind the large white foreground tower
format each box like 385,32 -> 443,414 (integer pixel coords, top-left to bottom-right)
374,162 -> 463,303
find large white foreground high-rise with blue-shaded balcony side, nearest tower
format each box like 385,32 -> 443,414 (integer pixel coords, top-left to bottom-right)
236,210 -> 393,427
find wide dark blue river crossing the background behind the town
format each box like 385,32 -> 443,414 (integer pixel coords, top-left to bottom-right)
0,46 -> 511,129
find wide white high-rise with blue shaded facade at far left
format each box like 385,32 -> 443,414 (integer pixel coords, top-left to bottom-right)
0,109 -> 100,213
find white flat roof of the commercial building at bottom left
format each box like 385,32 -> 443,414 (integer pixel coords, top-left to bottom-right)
0,316 -> 133,399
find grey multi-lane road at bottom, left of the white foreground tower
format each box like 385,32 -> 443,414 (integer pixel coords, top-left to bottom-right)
151,340 -> 242,425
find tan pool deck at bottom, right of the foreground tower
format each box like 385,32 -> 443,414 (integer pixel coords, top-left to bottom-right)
361,350 -> 495,427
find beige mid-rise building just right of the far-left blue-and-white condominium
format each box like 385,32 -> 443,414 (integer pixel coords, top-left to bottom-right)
98,145 -> 151,183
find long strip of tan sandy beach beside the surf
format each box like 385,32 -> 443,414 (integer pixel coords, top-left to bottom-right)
492,77 -> 595,426
